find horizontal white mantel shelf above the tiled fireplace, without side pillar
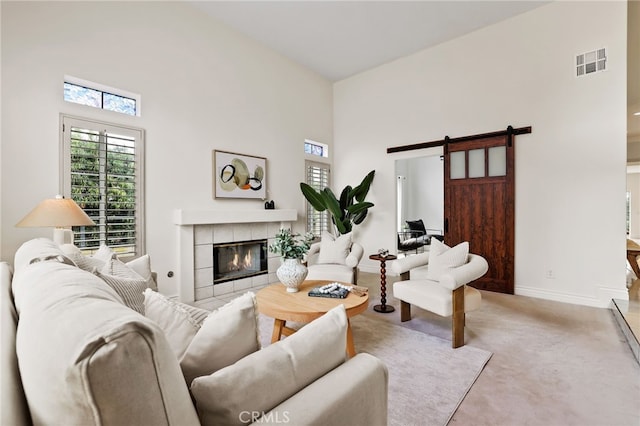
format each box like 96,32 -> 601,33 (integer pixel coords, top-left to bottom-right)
173,209 -> 298,225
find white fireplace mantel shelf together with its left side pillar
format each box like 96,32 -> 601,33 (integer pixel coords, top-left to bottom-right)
173,209 -> 298,303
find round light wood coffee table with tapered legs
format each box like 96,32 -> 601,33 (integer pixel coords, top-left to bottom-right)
256,280 -> 369,357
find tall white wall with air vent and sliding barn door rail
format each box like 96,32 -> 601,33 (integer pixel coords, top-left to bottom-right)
334,2 -> 627,306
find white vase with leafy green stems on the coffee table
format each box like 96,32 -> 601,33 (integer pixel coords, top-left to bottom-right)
269,228 -> 313,293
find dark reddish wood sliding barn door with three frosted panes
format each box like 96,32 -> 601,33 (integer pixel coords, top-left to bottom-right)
444,135 -> 515,294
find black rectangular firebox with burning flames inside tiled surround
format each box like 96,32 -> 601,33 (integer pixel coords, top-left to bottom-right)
213,240 -> 269,285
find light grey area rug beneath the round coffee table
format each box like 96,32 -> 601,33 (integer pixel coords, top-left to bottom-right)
260,315 -> 491,426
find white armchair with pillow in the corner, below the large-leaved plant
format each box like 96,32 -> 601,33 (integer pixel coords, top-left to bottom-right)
306,233 -> 364,284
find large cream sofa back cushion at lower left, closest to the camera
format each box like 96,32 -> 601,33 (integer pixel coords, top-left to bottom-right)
13,240 -> 198,425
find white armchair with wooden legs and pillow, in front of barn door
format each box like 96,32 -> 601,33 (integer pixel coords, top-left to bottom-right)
391,239 -> 489,348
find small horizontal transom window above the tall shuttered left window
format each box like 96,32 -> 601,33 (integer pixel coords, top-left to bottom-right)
64,76 -> 140,115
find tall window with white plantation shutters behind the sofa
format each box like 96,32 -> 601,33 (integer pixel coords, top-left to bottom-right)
60,116 -> 144,256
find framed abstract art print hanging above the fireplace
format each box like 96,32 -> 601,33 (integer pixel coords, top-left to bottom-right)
212,150 -> 267,200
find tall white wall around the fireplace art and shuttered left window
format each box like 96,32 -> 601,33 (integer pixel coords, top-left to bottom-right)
0,2 -> 332,294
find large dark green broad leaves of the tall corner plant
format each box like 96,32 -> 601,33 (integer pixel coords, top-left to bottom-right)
300,170 -> 376,235
